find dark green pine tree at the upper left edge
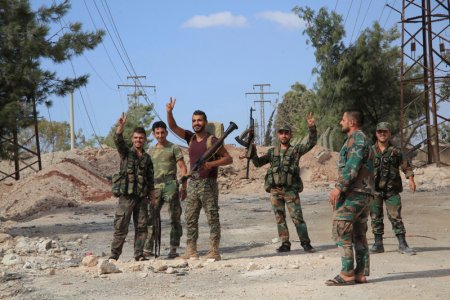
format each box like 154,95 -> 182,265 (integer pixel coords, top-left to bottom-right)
0,0 -> 104,157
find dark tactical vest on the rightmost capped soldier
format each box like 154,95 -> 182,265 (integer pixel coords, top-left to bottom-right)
374,145 -> 401,194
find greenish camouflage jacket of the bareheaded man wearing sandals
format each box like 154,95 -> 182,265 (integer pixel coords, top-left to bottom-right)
336,130 -> 374,194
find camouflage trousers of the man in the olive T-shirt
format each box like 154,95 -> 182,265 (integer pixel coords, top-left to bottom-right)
144,180 -> 183,252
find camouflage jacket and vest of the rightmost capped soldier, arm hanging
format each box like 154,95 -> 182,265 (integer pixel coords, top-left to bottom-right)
372,143 -> 414,196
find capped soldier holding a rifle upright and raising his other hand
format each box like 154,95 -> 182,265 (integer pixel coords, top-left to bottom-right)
252,114 -> 317,252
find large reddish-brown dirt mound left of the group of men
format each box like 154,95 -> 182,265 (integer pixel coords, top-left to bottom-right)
0,152 -> 112,220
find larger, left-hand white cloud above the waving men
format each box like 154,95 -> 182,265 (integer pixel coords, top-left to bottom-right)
182,11 -> 247,28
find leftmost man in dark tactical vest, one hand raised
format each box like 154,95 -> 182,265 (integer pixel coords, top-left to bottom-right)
110,114 -> 154,261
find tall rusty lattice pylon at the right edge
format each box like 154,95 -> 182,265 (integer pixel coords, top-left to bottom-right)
400,0 -> 450,167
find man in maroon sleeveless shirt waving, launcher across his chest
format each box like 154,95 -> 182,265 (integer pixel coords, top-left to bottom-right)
166,98 -> 233,260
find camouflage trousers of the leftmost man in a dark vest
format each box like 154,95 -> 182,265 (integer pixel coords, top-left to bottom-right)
111,196 -> 148,259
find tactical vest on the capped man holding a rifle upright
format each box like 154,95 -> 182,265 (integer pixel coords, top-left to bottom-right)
264,145 -> 303,193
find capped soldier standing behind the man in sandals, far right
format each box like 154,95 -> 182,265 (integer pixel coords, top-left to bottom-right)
370,122 -> 416,255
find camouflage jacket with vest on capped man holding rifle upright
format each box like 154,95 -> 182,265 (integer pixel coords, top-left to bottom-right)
251,126 -> 317,193
